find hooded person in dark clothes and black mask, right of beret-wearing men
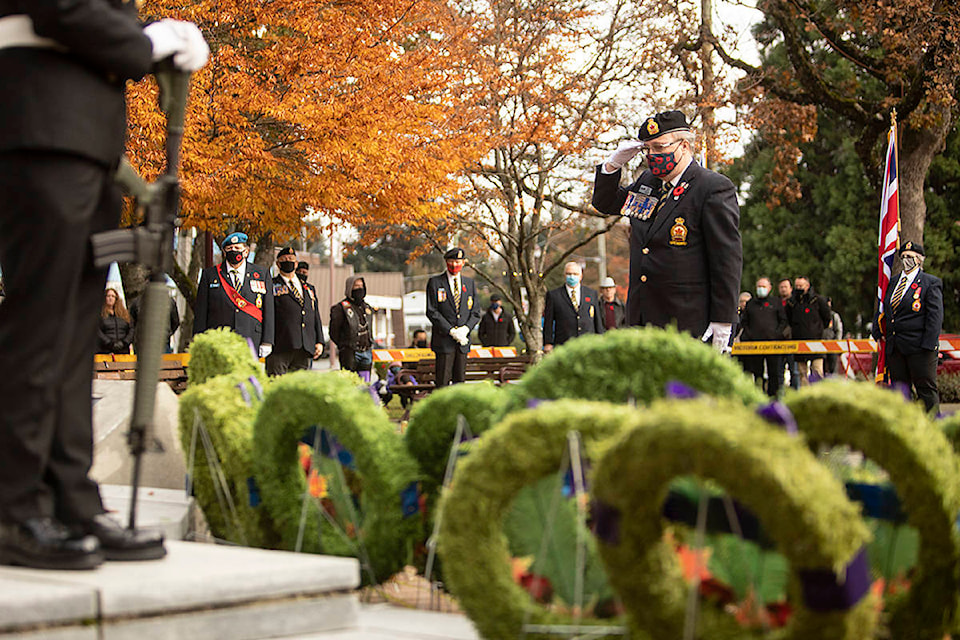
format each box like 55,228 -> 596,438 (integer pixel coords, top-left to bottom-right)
330,276 -> 374,382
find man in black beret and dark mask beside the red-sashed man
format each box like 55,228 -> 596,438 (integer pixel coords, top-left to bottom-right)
267,247 -> 323,376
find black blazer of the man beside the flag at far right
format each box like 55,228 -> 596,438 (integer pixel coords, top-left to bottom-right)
873,271 -> 943,356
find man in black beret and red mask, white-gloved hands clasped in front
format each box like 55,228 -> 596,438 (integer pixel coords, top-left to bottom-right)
427,247 -> 480,387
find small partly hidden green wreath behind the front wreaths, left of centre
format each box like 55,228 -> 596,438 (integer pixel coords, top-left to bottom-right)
404,382 -> 508,495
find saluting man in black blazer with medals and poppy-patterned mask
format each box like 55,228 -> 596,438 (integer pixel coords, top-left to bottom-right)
593,111 -> 743,351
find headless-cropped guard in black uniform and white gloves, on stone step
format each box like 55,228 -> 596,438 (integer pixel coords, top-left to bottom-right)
0,0 -> 208,569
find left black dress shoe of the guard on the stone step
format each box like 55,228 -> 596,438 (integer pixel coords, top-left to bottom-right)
0,517 -> 103,569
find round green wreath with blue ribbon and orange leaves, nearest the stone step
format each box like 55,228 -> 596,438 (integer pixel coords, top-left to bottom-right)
253,371 -> 420,582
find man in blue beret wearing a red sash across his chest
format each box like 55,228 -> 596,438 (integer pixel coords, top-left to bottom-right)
193,232 -> 274,358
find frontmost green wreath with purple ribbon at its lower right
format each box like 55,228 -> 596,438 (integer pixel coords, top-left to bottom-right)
593,398 -> 877,640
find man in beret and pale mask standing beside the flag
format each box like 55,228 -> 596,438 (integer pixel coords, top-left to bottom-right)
873,241 -> 943,415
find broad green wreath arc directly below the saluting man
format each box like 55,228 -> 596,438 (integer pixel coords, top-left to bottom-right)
509,327 -> 766,410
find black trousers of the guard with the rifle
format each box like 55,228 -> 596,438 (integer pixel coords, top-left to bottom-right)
0,152 -> 121,522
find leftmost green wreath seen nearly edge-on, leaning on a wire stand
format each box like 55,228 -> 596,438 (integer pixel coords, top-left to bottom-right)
179,373 -> 276,547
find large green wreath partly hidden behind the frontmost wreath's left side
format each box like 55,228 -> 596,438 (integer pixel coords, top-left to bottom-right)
438,400 -> 638,640
